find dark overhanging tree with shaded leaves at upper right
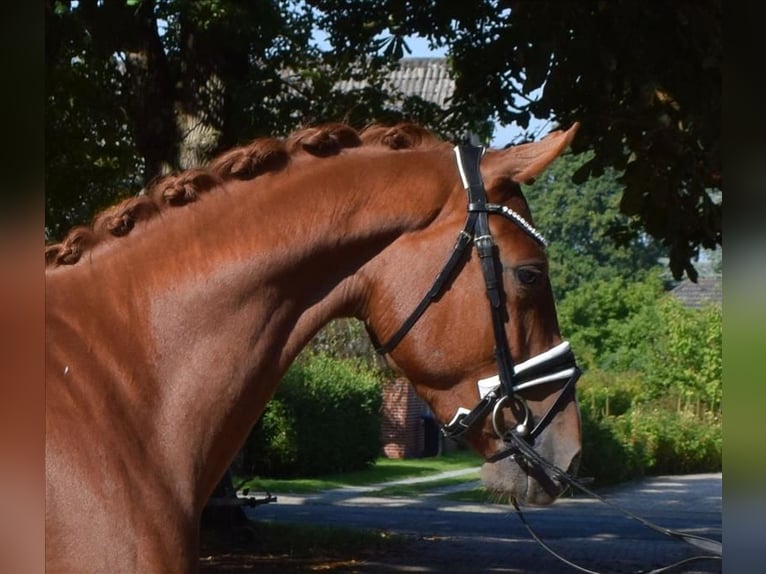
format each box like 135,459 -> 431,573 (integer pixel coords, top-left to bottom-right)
311,0 -> 723,279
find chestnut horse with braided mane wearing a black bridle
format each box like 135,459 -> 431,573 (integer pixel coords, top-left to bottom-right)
45,123 -> 581,573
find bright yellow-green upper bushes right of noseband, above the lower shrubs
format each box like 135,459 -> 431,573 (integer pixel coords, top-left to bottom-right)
559,275 -> 723,414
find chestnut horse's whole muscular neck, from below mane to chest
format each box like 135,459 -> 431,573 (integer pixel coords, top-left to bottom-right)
46,148 -> 456,505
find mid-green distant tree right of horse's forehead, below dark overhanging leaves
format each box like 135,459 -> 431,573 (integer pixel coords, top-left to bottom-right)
523,153 -> 665,302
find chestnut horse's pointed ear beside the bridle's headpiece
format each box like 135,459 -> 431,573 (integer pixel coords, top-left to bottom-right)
481,122 -> 580,183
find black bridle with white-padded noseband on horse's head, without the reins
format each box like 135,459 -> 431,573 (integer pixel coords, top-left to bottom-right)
377,145 -> 580,456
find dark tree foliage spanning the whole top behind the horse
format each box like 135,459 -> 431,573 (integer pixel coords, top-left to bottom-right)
45,0 -> 723,278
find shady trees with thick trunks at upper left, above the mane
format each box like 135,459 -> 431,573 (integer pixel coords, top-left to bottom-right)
46,0 -> 308,236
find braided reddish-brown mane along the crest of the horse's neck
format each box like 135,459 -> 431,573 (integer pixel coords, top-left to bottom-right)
45,123 -> 441,267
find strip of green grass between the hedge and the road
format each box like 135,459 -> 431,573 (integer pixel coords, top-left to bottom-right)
234,451 -> 483,493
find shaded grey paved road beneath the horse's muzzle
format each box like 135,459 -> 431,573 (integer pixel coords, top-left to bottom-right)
248,474 -> 722,574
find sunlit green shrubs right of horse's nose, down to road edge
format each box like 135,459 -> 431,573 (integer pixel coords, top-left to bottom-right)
559,274 -> 723,484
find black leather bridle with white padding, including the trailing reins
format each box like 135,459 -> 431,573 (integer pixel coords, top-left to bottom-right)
376,145 -> 723,574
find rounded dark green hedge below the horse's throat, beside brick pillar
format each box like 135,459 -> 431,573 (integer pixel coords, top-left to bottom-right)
237,353 -> 382,478
